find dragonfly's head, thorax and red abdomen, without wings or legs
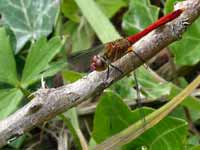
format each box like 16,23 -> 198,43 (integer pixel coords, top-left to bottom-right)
91,9 -> 184,71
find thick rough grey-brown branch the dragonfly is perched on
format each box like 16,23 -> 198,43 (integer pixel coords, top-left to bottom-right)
0,0 -> 200,147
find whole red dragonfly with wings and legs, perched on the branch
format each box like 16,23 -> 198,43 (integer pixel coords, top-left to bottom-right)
68,9 -> 184,74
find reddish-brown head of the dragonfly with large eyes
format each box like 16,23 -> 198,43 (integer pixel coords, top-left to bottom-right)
90,55 -> 106,71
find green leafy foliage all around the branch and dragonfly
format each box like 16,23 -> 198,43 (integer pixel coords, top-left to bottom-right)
0,0 -> 200,150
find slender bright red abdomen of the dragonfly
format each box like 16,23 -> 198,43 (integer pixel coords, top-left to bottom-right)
127,9 -> 184,44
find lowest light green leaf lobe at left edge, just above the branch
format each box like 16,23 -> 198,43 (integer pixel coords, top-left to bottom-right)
0,89 -> 23,120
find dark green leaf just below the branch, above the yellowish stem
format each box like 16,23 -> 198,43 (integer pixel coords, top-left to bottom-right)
92,92 -> 133,143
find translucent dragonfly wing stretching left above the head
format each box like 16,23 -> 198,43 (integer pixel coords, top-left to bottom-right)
68,44 -> 105,72
